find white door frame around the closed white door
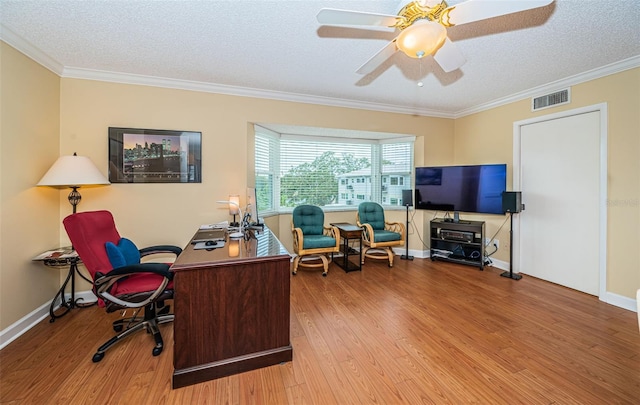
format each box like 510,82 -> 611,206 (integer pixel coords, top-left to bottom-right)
511,103 -> 608,301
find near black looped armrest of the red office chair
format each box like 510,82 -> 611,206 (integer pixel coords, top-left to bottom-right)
93,263 -> 173,308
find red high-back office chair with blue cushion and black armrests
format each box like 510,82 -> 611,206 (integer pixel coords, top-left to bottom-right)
63,211 -> 182,363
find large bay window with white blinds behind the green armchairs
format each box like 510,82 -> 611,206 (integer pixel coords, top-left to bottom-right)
255,125 -> 414,212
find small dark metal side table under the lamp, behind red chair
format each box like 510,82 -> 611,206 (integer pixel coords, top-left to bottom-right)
33,246 -> 98,322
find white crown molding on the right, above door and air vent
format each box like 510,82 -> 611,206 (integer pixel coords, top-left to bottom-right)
453,56 -> 640,118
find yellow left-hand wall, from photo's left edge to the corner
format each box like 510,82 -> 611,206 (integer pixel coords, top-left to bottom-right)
0,42 -> 61,330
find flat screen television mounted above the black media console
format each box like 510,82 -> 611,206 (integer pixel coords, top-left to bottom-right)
414,164 -> 507,214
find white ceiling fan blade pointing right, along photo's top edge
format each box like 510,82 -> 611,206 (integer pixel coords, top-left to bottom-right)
442,0 -> 554,25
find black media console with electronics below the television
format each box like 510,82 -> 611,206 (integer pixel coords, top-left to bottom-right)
430,218 -> 484,270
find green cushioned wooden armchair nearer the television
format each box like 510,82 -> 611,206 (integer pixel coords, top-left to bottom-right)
356,201 -> 405,267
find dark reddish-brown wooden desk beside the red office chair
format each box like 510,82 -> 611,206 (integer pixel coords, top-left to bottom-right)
171,227 -> 293,388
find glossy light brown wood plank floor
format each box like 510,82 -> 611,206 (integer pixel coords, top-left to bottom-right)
0,257 -> 640,405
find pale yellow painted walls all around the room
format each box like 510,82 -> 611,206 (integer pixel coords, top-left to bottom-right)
0,39 -> 640,330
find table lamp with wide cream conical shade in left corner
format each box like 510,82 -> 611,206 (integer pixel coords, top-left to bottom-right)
37,152 -> 111,214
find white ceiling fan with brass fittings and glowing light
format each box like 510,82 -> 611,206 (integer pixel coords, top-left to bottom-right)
317,0 -> 554,74
